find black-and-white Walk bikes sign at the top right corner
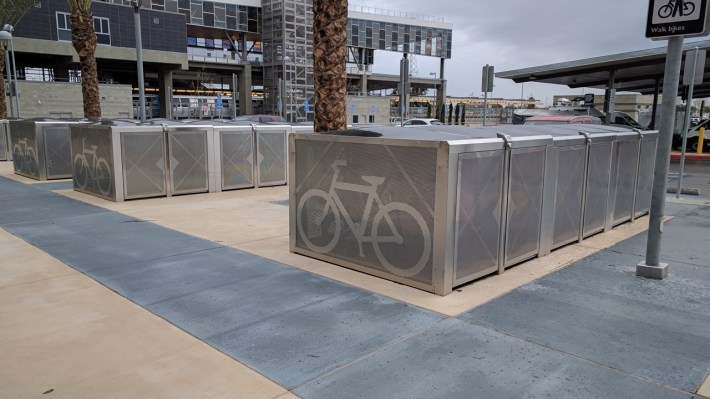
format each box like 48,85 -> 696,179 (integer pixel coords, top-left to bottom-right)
646,0 -> 710,40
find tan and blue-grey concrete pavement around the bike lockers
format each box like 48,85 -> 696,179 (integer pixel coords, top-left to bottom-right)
0,163 -> 710,398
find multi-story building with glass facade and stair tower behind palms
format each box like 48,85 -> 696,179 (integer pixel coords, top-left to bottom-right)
8,0 -> 453,122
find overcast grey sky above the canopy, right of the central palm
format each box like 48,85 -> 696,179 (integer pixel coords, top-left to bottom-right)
350,0 -> 706,104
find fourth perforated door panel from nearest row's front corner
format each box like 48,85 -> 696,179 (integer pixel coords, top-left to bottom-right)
583,142 -> 612,237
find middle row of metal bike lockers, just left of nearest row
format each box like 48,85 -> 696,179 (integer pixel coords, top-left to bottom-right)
71,120 -> 292,201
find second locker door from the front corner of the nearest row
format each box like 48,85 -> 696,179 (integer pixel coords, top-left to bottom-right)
499,134 -> 552,272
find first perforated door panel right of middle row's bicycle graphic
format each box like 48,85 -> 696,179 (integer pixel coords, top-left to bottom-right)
121,131 -> 166,199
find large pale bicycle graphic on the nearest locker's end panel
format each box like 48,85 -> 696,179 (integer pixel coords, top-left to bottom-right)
297,160 -> 432,277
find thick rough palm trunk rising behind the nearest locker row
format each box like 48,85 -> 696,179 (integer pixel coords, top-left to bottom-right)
313,0 -> 348,132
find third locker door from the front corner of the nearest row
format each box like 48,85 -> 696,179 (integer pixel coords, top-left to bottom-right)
540,135 -> 587,256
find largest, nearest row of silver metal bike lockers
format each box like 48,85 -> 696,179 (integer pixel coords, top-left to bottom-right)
289,125 -> 658,295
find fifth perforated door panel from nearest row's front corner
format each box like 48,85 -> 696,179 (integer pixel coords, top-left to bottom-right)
613,140 -> 639,225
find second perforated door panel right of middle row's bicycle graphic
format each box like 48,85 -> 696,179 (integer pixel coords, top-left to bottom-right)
168,130 -> 209,194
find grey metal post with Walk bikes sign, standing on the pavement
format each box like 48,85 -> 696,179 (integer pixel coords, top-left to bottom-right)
636,0 -> 708,280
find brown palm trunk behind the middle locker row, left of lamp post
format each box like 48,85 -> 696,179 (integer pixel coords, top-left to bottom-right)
68,0 -> 101,119
